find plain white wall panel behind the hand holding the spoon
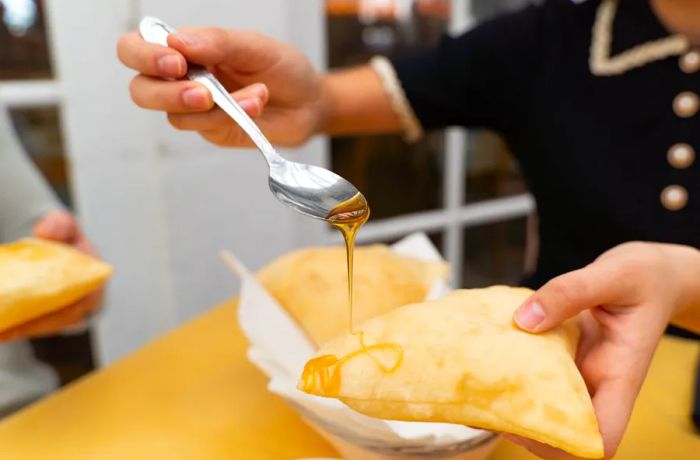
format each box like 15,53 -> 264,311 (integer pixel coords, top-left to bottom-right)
47,0 -> 327,364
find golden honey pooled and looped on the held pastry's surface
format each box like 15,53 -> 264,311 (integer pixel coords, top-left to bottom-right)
301,331 -> 403,398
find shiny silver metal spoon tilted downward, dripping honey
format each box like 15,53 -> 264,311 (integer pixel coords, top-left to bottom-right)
139,17 -> 366,221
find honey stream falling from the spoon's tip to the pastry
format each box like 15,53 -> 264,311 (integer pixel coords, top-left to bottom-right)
326,192 -> 369,333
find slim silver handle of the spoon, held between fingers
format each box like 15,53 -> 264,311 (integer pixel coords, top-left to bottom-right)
139,17 -> 284,166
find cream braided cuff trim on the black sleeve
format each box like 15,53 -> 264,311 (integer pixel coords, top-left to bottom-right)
369,56 -> 423,142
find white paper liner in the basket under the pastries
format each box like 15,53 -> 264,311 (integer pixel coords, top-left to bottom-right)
225,233 -> 484,446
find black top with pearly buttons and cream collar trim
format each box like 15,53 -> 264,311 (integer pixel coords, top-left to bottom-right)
392,0 -> 700,296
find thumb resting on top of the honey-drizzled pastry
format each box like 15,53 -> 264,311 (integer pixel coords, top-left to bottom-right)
513,260 -> 623,332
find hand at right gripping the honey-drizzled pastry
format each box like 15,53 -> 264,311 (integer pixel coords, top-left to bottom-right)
511,242 -> 700,458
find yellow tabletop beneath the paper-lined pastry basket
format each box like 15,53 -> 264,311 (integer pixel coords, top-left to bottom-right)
0,302 -> 700,460
